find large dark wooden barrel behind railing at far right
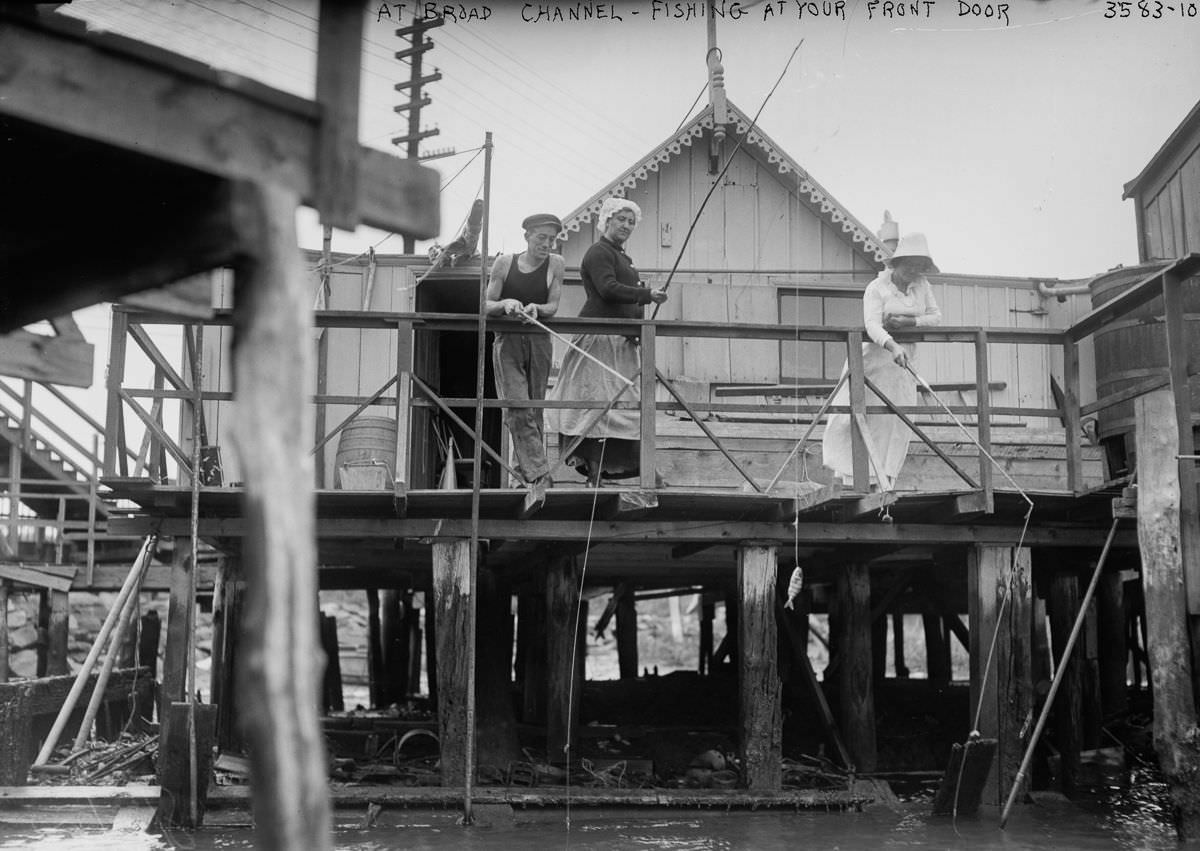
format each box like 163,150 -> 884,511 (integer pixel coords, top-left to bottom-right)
1091,262 -> 1200,449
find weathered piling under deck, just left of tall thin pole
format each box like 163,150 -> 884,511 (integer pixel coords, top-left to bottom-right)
433,539 -> 475,786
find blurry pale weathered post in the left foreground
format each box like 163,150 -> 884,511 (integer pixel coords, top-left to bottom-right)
226,178 -> 332,851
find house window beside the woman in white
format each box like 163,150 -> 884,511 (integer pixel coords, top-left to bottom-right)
779,289 -> 863,383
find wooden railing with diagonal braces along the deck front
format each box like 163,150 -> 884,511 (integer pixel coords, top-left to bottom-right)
104,302 -> 1082,508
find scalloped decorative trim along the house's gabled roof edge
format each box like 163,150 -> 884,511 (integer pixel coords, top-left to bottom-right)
563,102 -> 892,263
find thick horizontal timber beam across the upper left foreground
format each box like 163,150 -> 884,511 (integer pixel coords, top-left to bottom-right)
0,10 -> 440,238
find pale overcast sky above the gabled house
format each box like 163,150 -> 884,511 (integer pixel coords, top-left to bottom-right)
64,0 -> 1200,278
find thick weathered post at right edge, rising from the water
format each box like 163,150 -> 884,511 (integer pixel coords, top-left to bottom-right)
1134,390 -> 1200,841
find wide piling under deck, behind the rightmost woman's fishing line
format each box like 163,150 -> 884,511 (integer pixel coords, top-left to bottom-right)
967,545 -> 1033,804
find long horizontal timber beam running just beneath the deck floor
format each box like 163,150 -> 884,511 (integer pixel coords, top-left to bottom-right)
108,516 -> 1138,549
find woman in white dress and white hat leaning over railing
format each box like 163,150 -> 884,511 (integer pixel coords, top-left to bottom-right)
821,233 -> 942,490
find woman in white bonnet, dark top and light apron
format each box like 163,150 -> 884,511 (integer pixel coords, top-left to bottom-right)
546,198 -> 667,485
